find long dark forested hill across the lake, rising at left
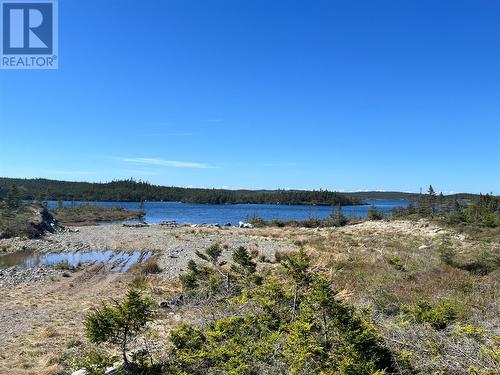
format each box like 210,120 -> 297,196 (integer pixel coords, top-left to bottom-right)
0,178 -> 361,205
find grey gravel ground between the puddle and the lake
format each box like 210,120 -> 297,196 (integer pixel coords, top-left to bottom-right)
0,224 -> 296,279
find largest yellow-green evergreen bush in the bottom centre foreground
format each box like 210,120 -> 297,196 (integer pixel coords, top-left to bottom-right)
167,250 -> 395,374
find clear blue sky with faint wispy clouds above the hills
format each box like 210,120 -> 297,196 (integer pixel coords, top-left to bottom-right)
0,0 -> 500,194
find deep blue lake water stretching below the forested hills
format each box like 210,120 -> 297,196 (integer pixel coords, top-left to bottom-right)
44,199 -> 409,225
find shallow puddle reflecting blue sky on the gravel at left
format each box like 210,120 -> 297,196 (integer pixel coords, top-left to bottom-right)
0,250 -> 152,272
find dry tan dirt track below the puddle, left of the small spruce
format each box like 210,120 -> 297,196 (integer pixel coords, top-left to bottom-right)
0,266 -> 129,375
